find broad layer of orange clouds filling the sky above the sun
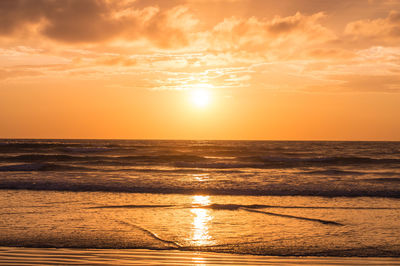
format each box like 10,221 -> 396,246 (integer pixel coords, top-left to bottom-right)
0,0 -> 400,96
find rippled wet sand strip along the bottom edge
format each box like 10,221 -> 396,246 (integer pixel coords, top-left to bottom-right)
0,247 -> 400,265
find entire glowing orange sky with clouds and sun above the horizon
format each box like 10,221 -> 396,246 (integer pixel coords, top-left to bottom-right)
0,0 -> 400,141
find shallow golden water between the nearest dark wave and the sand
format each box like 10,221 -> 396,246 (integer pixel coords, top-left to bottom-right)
0,190 -> 400,257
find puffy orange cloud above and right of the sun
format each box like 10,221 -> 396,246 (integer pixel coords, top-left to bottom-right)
209,12 -> 335,55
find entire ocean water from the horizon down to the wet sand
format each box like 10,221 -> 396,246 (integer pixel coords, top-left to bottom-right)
0,140 -> 400,257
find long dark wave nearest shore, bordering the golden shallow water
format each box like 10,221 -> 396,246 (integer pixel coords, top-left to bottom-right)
0,178 -> 400,198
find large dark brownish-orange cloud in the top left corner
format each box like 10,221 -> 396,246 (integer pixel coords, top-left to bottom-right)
0,0 -> 197,48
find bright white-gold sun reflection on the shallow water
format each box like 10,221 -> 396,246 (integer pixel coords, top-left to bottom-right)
190,196 -> 214,246
